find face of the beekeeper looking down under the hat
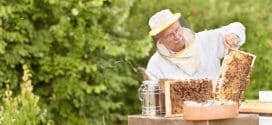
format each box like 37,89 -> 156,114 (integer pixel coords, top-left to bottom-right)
155,22 -> 185,52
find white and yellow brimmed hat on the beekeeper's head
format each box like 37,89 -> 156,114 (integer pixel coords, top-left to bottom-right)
148,9 -> 180,36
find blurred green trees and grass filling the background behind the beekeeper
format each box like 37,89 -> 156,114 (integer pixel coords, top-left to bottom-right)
0,0 -> 272,125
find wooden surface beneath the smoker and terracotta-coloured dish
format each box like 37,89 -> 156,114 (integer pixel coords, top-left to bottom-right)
128,114 -> 259,125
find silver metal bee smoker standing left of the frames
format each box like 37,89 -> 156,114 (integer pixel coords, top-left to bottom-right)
138,81 -> 161,116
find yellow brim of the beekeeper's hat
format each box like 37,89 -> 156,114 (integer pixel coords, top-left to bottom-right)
149,13 -> 181,36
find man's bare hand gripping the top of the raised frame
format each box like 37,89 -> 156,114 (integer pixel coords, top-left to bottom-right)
223,33 -> 239,48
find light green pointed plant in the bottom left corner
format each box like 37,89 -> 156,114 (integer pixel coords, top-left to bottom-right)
0,65 -> 52,125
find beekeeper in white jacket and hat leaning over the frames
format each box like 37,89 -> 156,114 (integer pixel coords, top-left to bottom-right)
145,9 -> 245,86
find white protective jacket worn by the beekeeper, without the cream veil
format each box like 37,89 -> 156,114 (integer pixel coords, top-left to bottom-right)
146,22 -> 245,85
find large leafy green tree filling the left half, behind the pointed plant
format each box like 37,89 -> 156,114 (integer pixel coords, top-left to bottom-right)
0,0 -> 152,125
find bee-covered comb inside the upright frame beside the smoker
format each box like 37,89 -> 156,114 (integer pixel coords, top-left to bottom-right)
170,79 -> 212,114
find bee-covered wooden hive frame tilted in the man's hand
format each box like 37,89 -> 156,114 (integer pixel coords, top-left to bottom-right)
215,49 -> 256,102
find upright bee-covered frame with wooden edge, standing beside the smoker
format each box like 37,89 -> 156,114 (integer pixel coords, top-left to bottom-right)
161,79 -> 212,117
